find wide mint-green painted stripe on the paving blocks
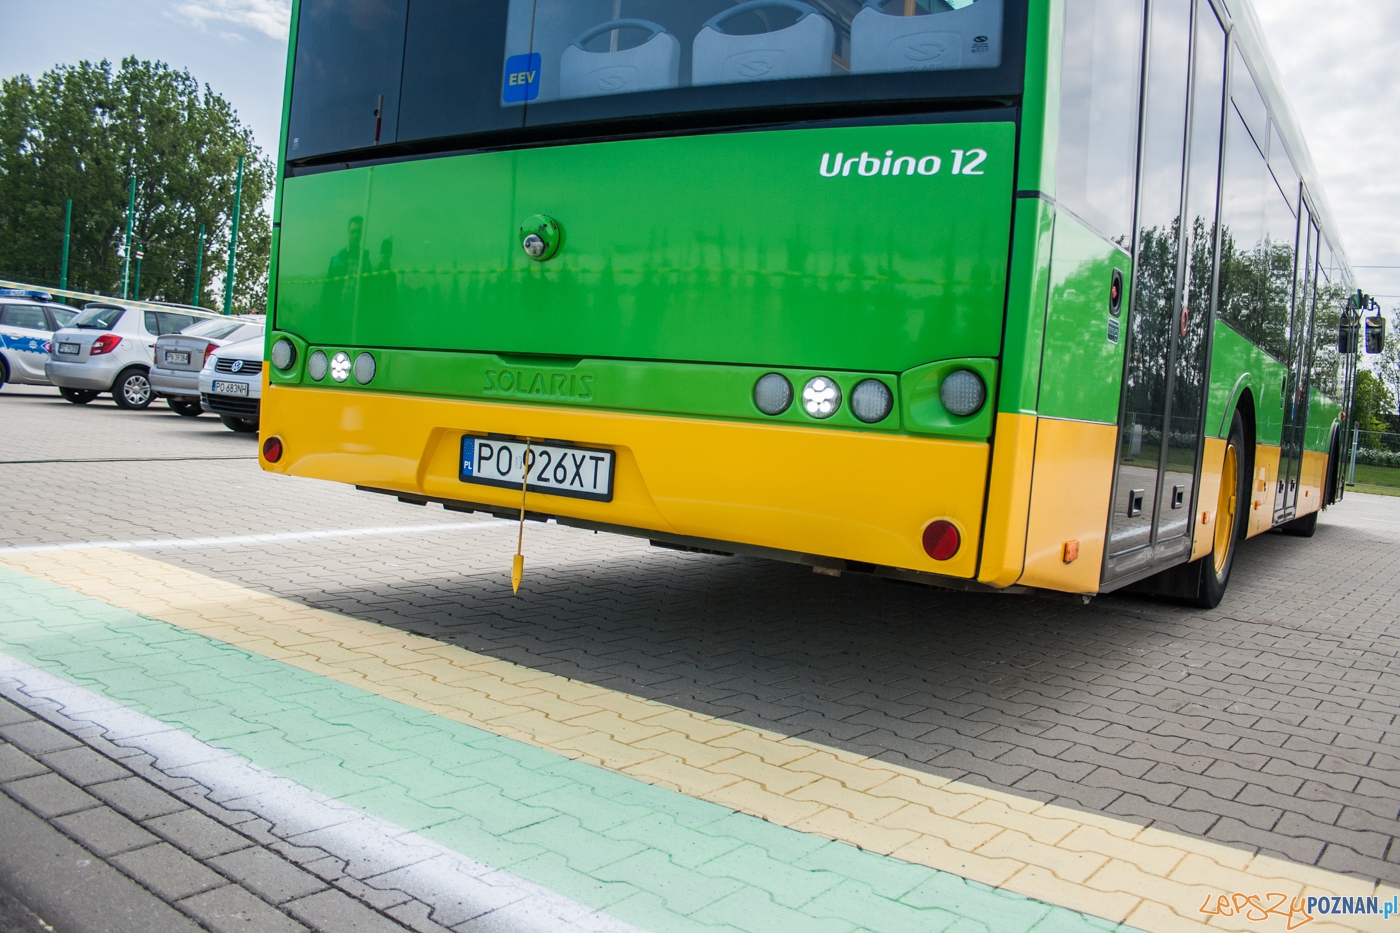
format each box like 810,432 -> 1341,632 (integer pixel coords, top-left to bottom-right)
0,570 -> 1127,933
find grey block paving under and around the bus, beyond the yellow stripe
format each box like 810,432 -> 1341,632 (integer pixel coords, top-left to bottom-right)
0,387 -> 1400,930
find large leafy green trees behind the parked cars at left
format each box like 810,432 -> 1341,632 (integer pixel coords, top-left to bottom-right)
0,57 -> 274,310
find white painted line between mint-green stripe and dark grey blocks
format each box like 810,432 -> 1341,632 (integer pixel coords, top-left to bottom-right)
0,653 -> 641,933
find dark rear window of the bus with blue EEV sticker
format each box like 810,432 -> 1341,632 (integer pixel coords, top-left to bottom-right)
287,0 -> 1026,163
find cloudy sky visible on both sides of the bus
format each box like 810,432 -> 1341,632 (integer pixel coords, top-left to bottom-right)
0,0 -> 1400,299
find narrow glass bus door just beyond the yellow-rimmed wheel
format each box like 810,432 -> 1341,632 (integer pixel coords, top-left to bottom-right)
1274,200 -> 1319,524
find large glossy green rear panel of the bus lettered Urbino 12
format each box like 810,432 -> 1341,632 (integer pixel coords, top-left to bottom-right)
276,123 -> 1015,373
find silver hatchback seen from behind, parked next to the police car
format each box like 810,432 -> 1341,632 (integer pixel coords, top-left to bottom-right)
43,301 -> 223,409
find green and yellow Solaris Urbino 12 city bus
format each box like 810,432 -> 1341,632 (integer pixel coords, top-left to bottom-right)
262,0 -> 1352,605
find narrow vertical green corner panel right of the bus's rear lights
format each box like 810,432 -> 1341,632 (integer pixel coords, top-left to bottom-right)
997,198 -> 1054,415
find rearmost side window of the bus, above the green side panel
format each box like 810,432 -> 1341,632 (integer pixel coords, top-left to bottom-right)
1054,0 -> 1142,248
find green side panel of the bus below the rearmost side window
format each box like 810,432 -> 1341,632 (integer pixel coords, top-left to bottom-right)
1039,213 -> 1133,424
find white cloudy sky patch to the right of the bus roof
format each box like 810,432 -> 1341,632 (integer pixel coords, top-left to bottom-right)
1254,0 -> 1400,298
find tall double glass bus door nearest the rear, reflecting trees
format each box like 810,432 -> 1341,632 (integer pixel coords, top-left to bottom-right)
1105,0 -> 1225,581
